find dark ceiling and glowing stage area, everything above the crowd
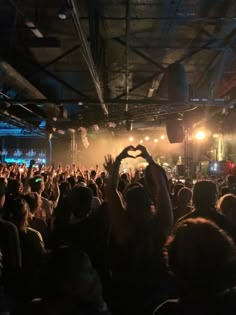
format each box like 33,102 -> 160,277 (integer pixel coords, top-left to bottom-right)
0,0 -> 236,178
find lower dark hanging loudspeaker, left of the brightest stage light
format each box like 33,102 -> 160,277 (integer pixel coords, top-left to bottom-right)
166,119 -> 184,143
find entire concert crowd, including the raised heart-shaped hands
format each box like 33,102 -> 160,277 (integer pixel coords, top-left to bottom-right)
0,145 -> 236,315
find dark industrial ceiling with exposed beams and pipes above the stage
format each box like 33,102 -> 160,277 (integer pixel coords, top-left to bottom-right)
0,0 -> 236,137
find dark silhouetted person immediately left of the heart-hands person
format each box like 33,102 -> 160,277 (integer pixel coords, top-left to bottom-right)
63,185 -> 110,304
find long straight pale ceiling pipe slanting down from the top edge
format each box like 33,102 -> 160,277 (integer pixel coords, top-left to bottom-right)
71,0 -> 108,116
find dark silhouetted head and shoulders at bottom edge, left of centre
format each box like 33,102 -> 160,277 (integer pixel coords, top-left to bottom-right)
39,246 -> 110,315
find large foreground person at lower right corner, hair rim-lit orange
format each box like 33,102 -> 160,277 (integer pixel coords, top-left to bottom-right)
154,218 -> 236,315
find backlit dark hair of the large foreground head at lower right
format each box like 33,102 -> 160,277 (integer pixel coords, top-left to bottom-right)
165,218 -> 236,294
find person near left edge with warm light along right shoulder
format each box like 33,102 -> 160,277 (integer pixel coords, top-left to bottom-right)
7,198 -> 46,300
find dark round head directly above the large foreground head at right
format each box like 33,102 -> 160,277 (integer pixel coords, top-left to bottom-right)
193,180 -> 218,211
